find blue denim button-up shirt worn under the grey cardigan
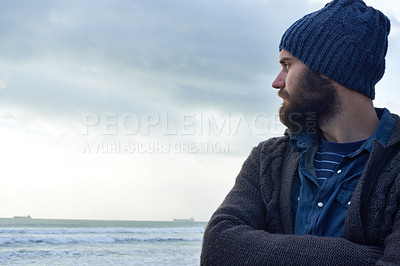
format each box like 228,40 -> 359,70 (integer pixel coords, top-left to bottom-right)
290,109 -> 395,237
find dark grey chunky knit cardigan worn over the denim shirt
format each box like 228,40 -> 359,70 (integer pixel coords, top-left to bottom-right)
201,115 -> 400,265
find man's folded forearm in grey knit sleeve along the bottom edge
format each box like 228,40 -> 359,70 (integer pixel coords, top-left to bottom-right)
201,215 -> 383,265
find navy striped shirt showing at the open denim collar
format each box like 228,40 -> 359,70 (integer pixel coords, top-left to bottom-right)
314,139 -> 364,185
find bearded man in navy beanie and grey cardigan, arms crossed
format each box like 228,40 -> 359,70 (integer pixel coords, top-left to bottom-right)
201,0 -> 400,265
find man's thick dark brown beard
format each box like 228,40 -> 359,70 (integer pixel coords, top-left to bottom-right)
278,69 -> 340,135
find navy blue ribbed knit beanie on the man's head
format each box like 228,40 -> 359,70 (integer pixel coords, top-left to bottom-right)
279,0 -> 390,99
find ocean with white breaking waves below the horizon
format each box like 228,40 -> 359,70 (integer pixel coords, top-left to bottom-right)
0,218 -> 206,265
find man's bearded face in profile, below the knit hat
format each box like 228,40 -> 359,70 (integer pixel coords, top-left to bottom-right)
272,50 -> 340,134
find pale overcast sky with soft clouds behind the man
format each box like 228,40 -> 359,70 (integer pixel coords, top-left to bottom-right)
0,0 -> 400,221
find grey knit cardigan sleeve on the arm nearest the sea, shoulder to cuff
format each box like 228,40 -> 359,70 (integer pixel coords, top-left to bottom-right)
201,142 -> 382,265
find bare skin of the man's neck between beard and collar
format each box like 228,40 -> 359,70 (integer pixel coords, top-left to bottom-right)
320,91 -> 379,143
